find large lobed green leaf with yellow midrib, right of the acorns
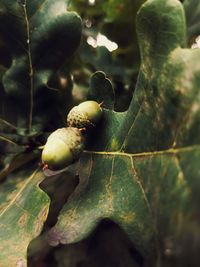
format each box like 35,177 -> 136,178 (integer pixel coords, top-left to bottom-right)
49,0 -> 200,266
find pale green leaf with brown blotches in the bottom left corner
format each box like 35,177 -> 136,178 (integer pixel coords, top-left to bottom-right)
0,169 -> 49,267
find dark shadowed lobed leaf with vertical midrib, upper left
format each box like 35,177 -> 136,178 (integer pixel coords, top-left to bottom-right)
0,0 -> 81,134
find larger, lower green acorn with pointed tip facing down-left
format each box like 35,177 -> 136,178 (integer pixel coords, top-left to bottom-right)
42,127 -> 84,170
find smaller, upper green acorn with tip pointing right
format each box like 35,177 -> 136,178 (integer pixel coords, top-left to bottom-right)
67,101 -> 102,128
